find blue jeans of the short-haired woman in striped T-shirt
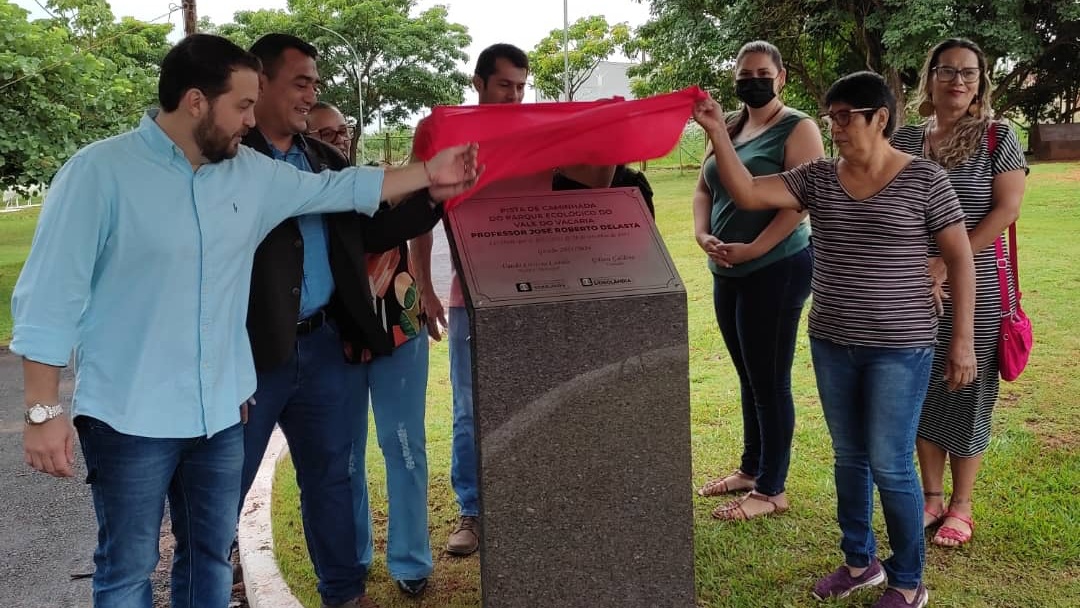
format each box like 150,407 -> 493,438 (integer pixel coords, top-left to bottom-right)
810,338 -> 934,589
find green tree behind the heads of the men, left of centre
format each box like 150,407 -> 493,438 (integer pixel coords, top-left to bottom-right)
203,0 -> 471,124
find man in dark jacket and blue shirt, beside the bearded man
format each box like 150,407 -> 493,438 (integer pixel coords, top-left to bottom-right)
242,33 -> 441,607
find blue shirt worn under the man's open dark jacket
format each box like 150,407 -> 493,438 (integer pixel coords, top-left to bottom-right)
267,140 -> 334,320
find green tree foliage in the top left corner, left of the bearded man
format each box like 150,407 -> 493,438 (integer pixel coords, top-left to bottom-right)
0,0 -> 172,189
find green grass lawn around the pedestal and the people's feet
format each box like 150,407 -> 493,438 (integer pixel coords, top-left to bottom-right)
273,163 -> 1080,608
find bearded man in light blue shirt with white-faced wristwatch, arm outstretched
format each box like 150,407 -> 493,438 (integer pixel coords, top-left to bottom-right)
11,35 -> 476,608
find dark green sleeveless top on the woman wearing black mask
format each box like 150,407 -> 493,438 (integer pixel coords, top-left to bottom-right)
702,108 -> 810,276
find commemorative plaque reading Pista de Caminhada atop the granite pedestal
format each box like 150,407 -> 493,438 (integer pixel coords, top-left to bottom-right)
449,188 -> 680,308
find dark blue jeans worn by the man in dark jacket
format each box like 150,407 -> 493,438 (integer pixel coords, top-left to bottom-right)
240,323 -> 367,604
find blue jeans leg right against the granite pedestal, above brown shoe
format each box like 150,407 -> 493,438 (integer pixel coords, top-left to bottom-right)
448,306 -> 480,517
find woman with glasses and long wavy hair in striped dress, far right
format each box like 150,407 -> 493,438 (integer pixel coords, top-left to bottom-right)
892,39 -> 1030,548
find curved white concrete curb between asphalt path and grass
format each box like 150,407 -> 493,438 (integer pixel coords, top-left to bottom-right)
239,428 -> 303,608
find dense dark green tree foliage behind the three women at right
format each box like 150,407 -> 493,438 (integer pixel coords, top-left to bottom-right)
630,0 -> 1080,122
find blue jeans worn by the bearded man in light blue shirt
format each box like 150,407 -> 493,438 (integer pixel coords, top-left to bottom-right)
75,416 -> 244,608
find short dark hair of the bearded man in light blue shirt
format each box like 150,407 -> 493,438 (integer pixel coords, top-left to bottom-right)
158,33 -> 262,112
